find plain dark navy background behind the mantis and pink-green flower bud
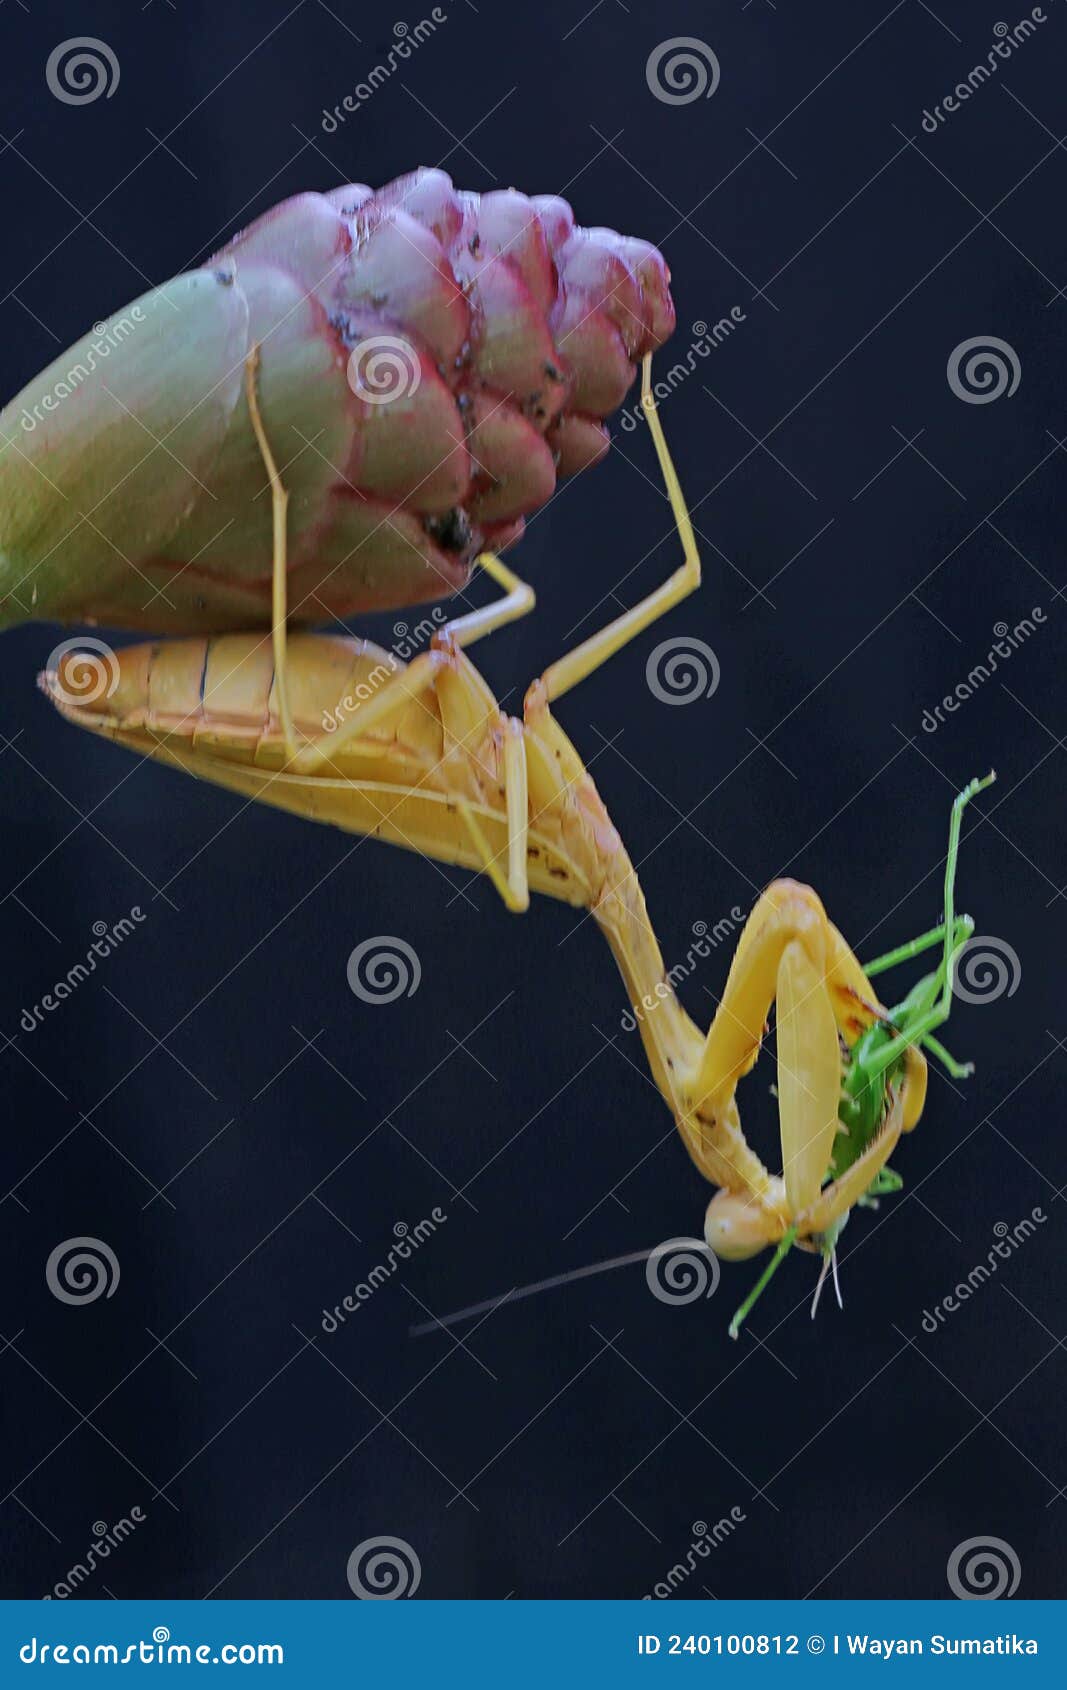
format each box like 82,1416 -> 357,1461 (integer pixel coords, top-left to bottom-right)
0,0 -> 1067,1597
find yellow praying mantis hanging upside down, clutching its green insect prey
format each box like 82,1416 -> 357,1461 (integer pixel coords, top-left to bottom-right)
41,353 -> 993,1335
